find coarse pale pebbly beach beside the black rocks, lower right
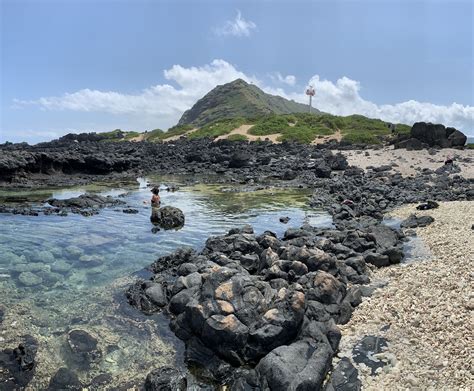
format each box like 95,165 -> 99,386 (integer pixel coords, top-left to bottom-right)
339,201 -> 474,391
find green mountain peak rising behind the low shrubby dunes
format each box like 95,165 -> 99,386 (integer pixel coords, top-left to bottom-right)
178,79 -> 319,127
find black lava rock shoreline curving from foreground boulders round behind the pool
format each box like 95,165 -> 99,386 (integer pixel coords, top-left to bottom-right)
0,140 -> 474,390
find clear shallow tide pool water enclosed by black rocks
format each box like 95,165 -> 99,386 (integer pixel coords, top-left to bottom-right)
0,178 -> 331,389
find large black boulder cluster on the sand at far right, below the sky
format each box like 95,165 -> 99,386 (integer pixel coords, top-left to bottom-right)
395,122 -> 467,150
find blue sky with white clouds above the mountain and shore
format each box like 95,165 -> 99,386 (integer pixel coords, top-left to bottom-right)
0,0 -> 474,143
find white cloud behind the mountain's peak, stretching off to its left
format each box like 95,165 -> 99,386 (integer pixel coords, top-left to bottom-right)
13,60 -> 260,129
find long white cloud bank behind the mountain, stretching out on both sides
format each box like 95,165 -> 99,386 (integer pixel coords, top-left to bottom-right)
14,60 -> 474,134
